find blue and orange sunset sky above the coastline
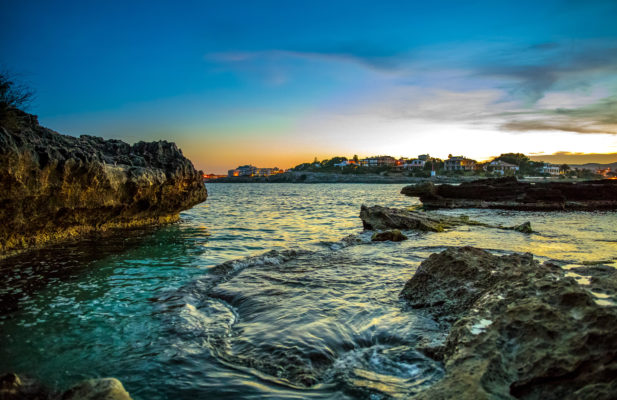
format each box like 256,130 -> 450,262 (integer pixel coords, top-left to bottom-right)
0,0 -> 617,173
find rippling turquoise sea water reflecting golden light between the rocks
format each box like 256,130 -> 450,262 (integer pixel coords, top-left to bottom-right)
0,184 -> 617,399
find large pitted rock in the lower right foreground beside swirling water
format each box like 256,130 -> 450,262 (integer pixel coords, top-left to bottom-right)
401,247 -> 617,400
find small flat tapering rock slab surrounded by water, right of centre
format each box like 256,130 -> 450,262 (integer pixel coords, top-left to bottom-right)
360,205 -> 533,233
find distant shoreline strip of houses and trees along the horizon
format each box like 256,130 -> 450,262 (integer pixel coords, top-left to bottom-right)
209,153 -> 617,180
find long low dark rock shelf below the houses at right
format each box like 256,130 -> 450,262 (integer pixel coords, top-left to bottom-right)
401,177 -> 617,210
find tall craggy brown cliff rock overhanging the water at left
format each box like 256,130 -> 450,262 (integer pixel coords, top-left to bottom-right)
0,110 -> 207,256
